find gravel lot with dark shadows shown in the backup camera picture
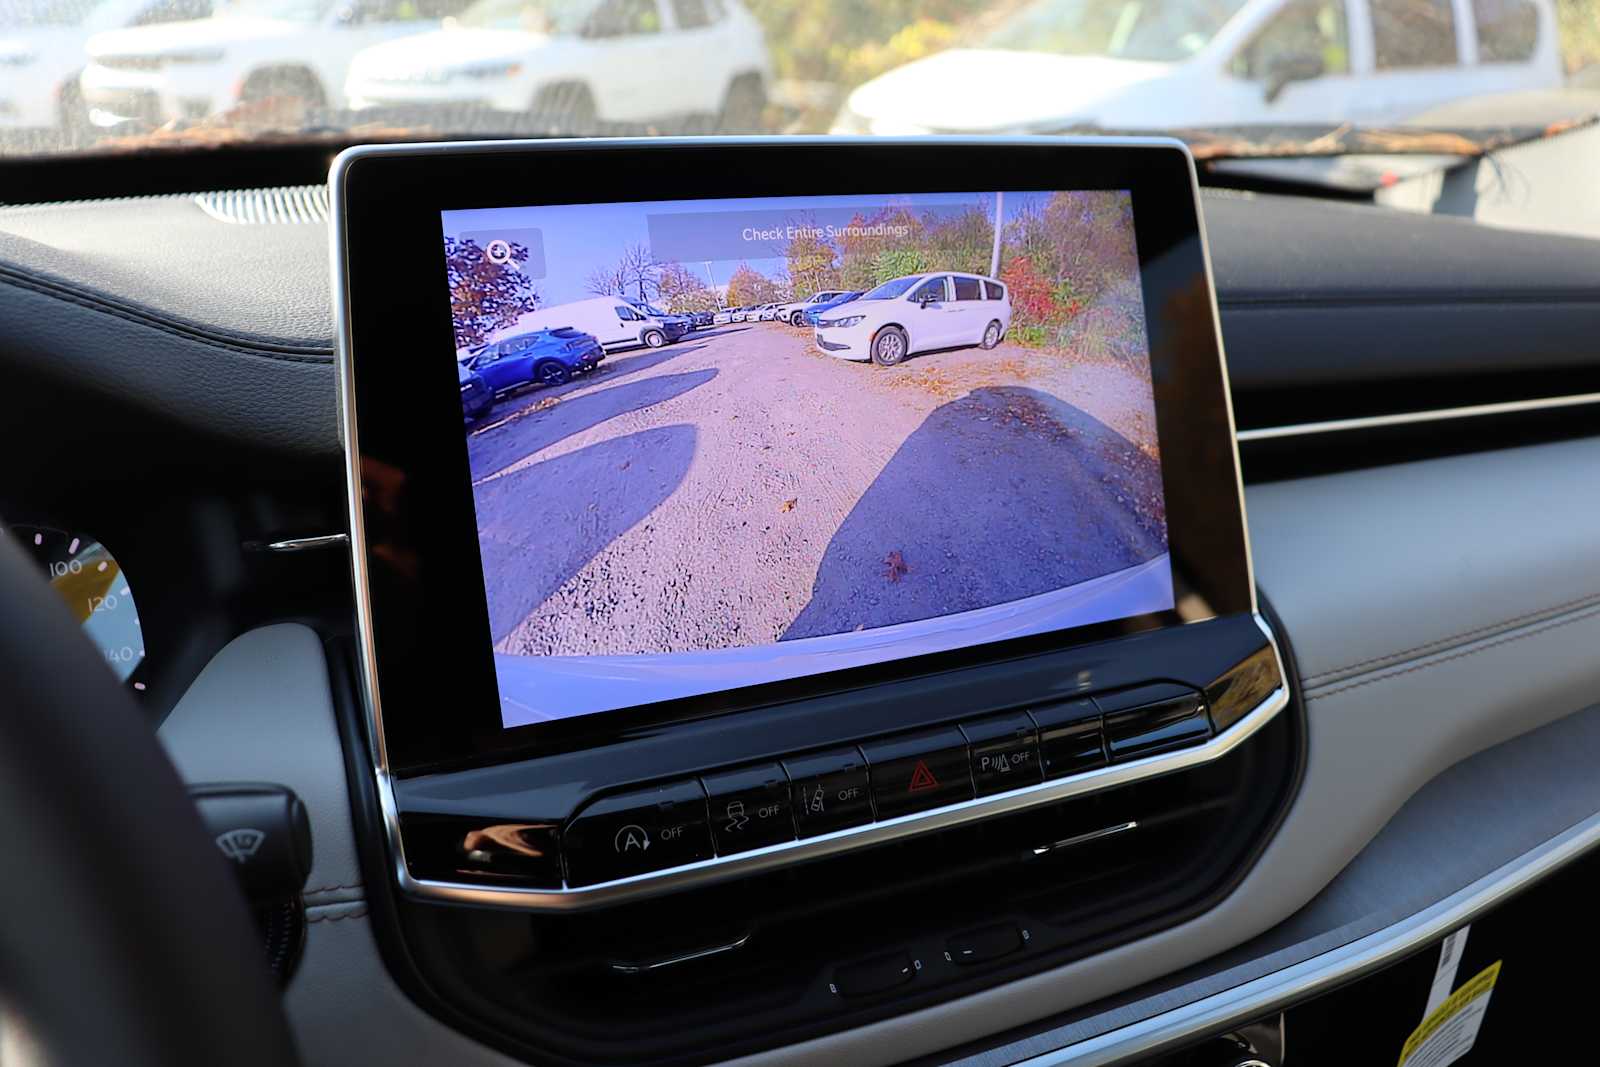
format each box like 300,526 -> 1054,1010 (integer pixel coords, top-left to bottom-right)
469,323 -> 1166,656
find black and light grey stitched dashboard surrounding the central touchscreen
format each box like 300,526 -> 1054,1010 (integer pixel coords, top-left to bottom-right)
0,143 -> 1600,1064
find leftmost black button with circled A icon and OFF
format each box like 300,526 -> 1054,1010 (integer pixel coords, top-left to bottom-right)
563,779 -> 712,886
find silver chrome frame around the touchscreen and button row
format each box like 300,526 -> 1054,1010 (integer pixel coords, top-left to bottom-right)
328,136 -> 1290,910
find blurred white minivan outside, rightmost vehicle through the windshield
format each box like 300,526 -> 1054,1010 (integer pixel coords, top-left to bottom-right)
834,0 -> 1563,134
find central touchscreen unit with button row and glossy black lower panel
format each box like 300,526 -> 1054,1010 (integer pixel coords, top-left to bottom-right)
333,139 -> 1302,1062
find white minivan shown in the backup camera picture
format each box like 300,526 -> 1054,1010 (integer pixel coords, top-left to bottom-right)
816,270 -> 1011,366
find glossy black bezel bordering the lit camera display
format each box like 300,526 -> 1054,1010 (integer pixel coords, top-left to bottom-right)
331,138 -> 1254,774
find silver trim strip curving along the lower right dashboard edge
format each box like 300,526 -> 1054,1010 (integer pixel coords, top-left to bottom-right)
1014,814 -> 1600,1067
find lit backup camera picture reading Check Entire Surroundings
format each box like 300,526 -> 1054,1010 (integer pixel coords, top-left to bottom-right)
440,190 -> 1173,726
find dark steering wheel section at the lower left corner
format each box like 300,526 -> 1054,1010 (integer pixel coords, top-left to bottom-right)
0,534 -> 299,1067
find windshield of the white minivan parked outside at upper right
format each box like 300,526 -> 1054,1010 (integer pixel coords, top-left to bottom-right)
981,0 -> 1245,62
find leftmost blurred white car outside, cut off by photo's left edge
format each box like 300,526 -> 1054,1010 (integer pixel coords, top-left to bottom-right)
0,0 -> 211,131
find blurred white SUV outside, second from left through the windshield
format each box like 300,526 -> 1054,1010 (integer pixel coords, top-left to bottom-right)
82,0 -> 450,125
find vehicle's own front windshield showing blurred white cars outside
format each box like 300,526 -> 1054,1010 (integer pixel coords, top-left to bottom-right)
0,0 -> 1600,211
